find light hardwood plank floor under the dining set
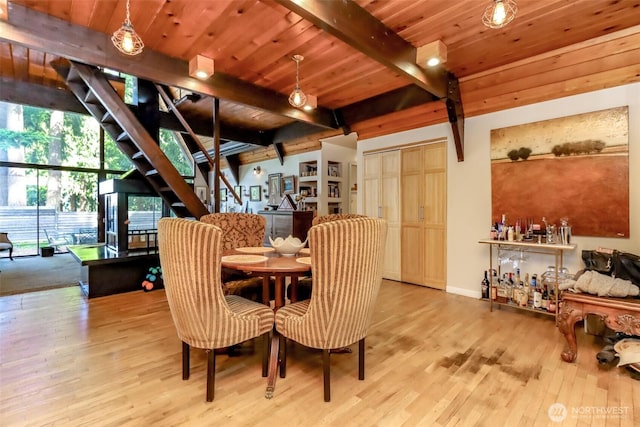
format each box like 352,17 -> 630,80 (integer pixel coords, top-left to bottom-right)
0,281 -> 640,427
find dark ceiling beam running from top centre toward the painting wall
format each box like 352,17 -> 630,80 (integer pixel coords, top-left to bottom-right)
276,0 -> 447,98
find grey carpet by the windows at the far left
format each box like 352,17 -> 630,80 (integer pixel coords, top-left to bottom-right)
0,253 -> 81,295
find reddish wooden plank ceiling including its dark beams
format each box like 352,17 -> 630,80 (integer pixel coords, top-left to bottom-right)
0,0 -> 640,163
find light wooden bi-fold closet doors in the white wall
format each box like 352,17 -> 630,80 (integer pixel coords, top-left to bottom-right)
363,140 -> 447,289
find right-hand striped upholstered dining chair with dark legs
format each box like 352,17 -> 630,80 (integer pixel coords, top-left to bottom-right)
276,217 -> 387,402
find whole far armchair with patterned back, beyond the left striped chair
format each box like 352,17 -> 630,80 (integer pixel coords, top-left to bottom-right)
200,212 -> 273,304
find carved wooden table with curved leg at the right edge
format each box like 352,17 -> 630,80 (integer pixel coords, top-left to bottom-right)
558,292 -> 640,363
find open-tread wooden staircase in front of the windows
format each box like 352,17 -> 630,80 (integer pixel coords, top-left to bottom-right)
52,60 -> 209,218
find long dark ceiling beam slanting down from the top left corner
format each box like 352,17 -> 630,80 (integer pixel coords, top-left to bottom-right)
0,3 -> 336,129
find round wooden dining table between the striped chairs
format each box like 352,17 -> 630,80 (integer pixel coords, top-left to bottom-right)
222,248 -> 311,399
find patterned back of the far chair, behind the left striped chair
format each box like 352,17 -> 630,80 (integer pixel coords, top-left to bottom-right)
200,212 -> 267,250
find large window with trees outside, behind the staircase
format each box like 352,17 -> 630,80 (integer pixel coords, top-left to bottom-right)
0,102 -> 194,256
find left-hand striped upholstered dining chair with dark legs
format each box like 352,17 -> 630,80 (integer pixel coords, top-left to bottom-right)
158,218 -> 273,402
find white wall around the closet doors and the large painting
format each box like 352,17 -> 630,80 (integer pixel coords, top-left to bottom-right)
357,83 -> 640,297
